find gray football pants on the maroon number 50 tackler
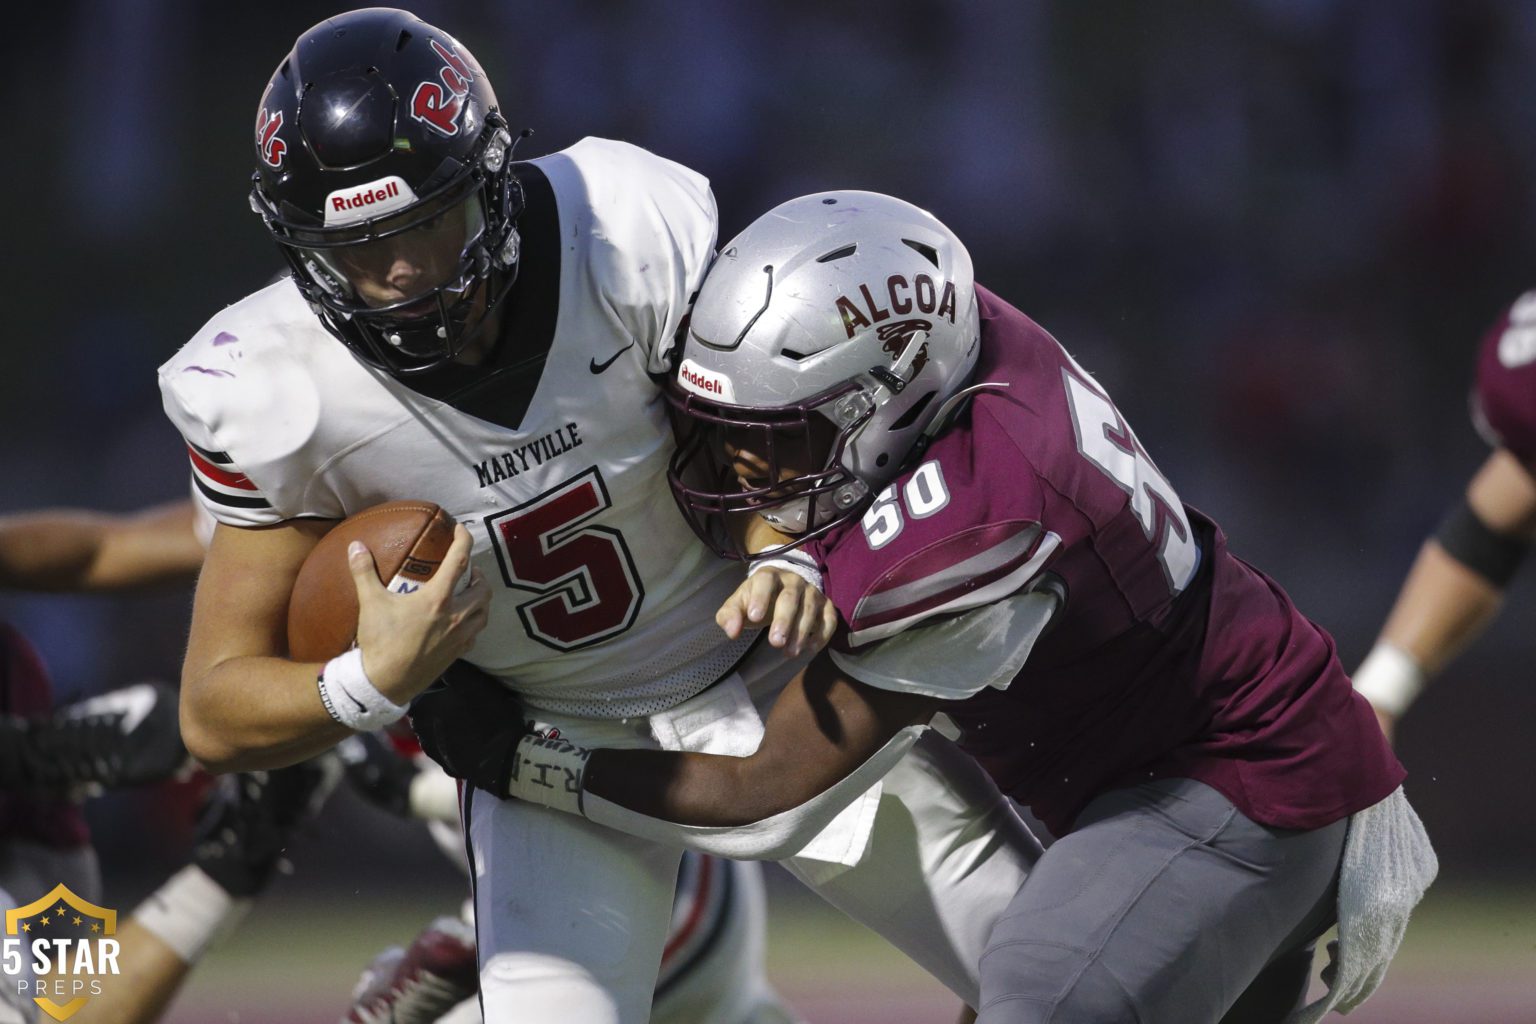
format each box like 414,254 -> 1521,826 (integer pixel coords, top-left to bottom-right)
977,778 -> 1347,1024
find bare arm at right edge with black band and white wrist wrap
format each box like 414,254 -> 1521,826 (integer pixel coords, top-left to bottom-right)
1355,448 -> 1536,735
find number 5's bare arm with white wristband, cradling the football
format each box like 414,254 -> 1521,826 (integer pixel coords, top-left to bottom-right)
181,519 -> 490,771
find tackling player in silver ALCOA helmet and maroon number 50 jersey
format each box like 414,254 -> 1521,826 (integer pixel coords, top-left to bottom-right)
413,192 -> 1435,1024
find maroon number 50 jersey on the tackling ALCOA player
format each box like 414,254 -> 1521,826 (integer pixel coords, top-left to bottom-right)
809,289 -> 1404,835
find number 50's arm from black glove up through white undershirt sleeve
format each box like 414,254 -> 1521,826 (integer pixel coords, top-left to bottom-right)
412,576 -> 1066,860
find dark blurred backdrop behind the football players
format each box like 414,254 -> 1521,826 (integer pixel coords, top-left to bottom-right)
0,0 -> 1536,951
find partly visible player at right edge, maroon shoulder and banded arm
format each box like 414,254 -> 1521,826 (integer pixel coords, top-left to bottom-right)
1355,292 -> 1536,737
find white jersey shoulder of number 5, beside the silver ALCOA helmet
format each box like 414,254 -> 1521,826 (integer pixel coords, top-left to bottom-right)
556,138 -> 719,375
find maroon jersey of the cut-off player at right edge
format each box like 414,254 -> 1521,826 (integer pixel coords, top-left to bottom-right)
1471,292 -> 1536,471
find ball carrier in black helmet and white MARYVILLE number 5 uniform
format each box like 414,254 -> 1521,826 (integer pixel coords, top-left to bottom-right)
160,9 -> 1038,1024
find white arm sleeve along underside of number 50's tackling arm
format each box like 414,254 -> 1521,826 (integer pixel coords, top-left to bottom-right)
581,725 -> 926,860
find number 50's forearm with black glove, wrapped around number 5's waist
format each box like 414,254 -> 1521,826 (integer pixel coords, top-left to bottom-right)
412,652 -> 937,860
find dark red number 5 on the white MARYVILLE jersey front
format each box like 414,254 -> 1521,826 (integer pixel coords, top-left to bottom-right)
485,467 -> 645,651
